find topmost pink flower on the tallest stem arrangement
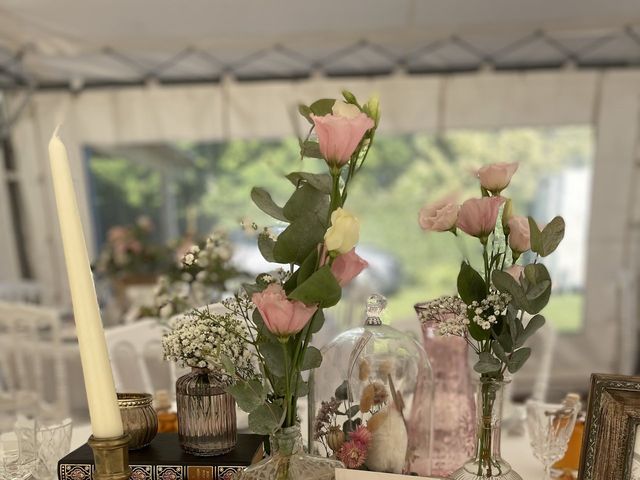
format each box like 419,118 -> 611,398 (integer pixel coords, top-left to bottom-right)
311,102 -> 374,167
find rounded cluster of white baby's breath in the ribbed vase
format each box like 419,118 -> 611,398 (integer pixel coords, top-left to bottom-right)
162,307 -> 255,382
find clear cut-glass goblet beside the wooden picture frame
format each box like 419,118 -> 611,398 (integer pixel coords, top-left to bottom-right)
526,400 -> 580,480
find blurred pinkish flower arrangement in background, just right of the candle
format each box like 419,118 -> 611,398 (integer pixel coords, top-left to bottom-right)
95,216 -> 169,279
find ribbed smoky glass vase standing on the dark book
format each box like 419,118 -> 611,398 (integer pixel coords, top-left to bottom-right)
176,368 -> 237,457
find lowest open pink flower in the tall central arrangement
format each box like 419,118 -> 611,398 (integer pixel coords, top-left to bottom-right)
251,283 -> 318,337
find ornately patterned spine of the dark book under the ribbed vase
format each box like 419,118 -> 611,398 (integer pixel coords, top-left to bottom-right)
58,463 -> 247,480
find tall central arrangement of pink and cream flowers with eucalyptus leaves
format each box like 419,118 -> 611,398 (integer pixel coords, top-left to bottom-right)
220,91 -> 380,438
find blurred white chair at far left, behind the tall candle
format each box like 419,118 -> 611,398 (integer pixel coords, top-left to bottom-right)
0,302 -> 69,418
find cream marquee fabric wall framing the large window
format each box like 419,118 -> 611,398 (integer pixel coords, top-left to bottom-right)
5,70 -> 640,390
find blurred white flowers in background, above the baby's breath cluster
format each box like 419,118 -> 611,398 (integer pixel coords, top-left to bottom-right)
139,231 -> 243,320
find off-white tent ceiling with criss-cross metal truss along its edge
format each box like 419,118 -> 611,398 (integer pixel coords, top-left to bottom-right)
0,0 -> 640,88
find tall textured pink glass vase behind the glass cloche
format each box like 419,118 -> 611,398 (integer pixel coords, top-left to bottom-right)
415,303 -> 475,477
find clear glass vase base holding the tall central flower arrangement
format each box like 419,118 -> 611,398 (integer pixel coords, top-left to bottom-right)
238,425 -> 344,480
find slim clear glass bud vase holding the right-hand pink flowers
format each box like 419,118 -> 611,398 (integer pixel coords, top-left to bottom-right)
450,377 -> 522,480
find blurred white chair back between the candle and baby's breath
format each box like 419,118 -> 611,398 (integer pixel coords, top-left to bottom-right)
105,318 -> 177,394
